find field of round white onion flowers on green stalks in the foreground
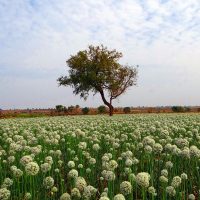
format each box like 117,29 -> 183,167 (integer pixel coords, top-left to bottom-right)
0,114 -> 200,200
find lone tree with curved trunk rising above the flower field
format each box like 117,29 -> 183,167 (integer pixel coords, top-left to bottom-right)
58,45 -> 137,116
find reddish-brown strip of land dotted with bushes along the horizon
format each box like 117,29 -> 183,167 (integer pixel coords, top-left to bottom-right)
0,105 -> 200,118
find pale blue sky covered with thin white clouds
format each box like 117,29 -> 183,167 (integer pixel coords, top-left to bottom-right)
0,0 -> 200,109
